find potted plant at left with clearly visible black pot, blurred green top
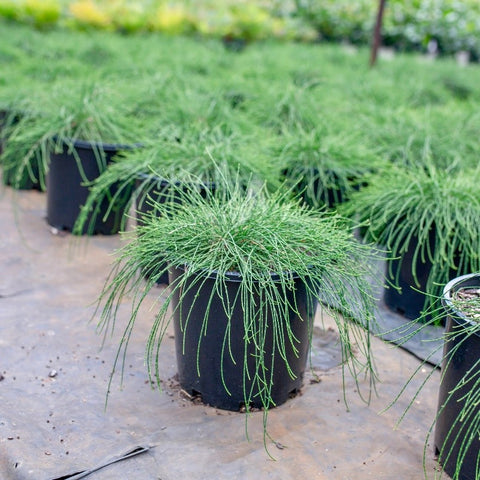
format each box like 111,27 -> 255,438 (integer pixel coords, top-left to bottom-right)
47,82 -> 146,234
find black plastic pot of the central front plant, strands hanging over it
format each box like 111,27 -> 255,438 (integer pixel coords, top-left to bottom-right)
169,268 -> 317,411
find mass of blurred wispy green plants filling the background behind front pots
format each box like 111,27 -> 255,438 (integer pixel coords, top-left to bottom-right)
0,17 -> 480,200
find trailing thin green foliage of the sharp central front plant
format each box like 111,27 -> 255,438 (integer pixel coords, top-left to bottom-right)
99,184 -> 375,448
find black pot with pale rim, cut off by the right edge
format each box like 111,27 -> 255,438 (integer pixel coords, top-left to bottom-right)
434,273 -> 480,480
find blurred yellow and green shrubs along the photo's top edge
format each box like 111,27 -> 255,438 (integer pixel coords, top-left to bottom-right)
0,0 -> 480,61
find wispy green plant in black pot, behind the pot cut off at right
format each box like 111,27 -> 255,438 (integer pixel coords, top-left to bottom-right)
340,160 -> 480,319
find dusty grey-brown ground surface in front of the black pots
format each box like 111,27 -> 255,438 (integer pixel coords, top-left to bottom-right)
0,189 -> 448,480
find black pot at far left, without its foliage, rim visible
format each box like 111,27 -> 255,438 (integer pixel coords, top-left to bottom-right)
47,140 -> 133,235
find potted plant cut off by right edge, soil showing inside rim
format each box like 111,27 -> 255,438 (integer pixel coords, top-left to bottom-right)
387,273 -> 480,480
